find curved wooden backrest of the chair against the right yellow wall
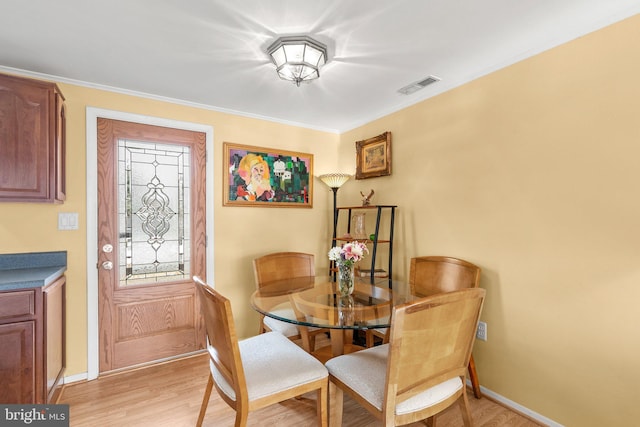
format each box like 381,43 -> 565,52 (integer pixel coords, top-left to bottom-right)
409,256 -> 480,296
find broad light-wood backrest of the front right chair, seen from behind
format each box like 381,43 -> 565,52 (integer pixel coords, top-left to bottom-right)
384,288 -> 486,419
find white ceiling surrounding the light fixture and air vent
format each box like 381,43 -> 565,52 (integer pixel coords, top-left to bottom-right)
0,0 -> 640,132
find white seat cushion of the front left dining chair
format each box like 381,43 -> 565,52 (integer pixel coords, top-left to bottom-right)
210,332 -> 328,401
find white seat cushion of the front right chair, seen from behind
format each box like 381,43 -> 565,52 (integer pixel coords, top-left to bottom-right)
325,344 -> 462,415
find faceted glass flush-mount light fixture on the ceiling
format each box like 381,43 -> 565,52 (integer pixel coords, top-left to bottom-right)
267,36 -> 327,86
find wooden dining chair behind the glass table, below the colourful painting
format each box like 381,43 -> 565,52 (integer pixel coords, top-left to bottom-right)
253,252 -> 328,352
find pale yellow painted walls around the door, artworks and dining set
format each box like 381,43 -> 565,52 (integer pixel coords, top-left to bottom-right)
0,12 -> 640,427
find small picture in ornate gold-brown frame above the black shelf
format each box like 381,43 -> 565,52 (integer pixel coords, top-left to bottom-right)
356,132 -> 391,179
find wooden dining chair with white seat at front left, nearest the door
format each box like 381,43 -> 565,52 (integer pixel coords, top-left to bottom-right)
193,276 -> 328,427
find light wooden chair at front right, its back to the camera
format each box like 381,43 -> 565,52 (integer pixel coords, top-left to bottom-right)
325,288 -> 486,427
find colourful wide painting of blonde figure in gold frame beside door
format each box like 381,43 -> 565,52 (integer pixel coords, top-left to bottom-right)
222,142 -> 313,208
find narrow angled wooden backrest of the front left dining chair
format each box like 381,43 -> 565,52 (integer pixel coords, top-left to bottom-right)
193,276 -> 248,407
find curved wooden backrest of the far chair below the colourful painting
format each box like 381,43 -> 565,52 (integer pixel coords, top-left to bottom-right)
253,252 -> 316,288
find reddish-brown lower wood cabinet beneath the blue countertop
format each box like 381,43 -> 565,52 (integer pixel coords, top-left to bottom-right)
0,276 -> 66,404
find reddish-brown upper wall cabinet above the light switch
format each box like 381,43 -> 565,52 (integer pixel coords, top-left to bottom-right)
0,74 -> 65,203
